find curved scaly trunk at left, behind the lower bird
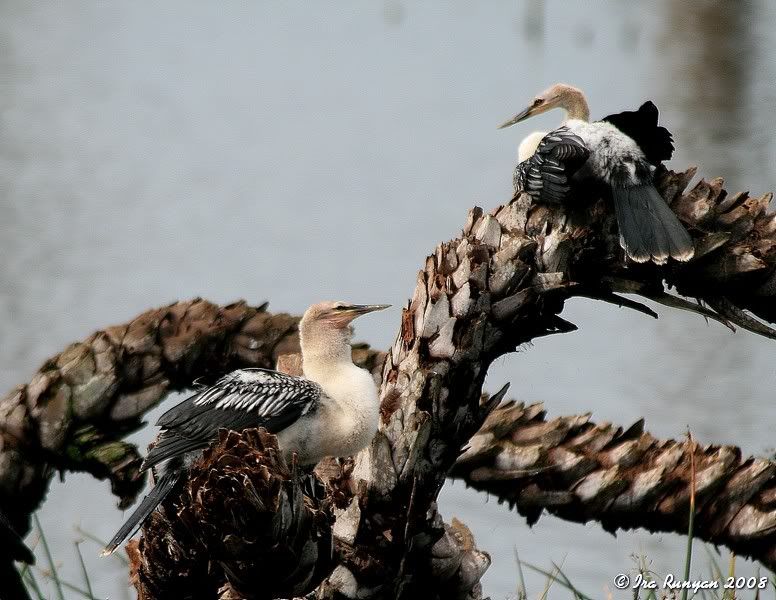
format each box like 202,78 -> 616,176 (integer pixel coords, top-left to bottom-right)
0,299 -> 296,531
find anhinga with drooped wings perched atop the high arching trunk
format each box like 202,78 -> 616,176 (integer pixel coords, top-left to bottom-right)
500,83 -> 694,264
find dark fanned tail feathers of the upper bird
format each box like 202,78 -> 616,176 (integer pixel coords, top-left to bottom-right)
612,183 -> 695,264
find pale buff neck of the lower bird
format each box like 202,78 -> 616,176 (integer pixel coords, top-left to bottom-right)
299,322 -> 353,383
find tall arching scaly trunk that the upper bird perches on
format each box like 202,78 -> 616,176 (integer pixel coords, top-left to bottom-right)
312,170 -> 776,598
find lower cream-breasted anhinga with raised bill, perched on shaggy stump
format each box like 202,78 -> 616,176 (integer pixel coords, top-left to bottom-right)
103,302 -> 389,555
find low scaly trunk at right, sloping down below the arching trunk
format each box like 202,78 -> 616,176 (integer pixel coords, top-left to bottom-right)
450,402 -> 776,569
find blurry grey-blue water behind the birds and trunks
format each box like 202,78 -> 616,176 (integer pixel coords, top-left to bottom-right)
0,0 -> 776,599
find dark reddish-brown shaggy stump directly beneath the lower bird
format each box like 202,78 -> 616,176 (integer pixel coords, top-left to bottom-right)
130,429 -> 337,599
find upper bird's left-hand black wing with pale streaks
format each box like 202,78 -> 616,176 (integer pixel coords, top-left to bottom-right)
514,127 -> 590,204
